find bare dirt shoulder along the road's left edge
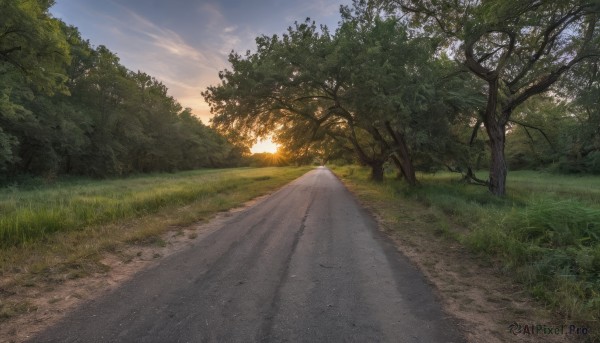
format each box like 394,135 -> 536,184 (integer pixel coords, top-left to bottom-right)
0,195 -> 269,343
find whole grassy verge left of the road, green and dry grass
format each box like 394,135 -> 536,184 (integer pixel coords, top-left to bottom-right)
0,167 -> 311,322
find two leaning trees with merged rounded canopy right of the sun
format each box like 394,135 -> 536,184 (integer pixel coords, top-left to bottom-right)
203,9 -> 464,185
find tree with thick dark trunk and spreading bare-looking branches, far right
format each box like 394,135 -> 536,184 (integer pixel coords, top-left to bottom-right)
384,0 -> 600,196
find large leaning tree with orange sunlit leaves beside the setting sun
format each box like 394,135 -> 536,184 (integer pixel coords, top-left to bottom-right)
203,21 -> 396,180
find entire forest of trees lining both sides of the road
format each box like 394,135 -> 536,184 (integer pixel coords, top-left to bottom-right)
0,0 -> 600,195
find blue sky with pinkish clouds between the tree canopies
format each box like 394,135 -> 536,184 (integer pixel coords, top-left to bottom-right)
51,0 -> 352,123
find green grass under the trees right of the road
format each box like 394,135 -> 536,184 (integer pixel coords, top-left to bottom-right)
333,166 -> 600,340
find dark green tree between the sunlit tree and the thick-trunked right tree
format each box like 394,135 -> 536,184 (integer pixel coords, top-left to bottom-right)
337,6 -> 488,184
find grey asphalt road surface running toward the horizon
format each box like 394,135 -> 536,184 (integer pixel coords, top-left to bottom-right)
32,168 -> 463,343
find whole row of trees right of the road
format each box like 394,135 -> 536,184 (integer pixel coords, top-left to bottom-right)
203,0 -> 600,195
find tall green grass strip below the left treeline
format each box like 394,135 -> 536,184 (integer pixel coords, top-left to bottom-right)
0,168 -> 307,247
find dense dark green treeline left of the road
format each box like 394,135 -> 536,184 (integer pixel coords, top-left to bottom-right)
0,0 -> 242,180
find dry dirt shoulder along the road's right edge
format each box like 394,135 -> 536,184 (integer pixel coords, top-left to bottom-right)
332,180 -> 576,343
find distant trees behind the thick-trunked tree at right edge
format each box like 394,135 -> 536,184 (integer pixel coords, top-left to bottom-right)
507,60 -> 600,174
